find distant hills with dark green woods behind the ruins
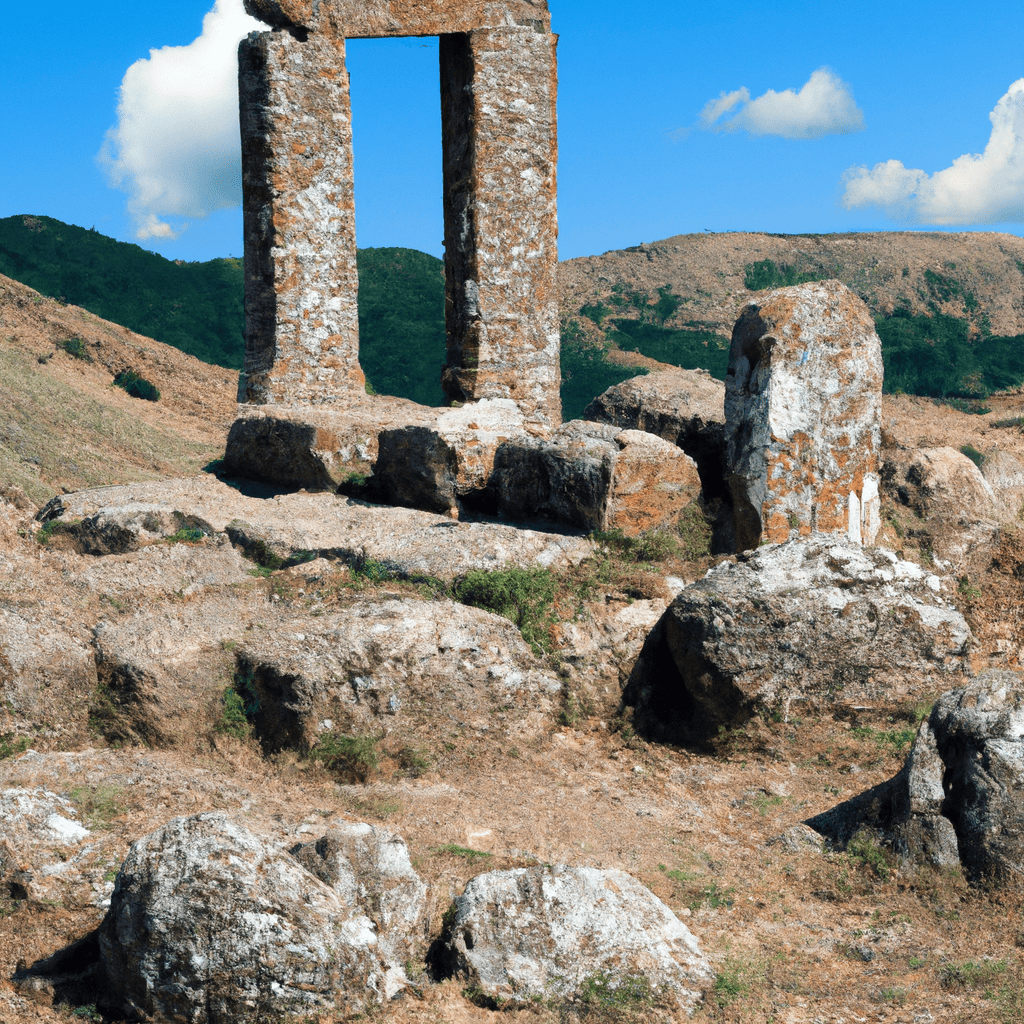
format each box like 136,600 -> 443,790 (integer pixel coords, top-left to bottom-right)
8,216 -> 1024,418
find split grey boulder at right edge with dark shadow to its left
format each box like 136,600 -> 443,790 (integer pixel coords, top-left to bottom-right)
807,671 -> 1024,887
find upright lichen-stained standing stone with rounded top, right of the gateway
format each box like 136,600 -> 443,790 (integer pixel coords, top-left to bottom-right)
725,281 -> 883,550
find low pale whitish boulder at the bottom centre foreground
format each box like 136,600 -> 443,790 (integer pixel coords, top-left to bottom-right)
439,864 -> 714,1013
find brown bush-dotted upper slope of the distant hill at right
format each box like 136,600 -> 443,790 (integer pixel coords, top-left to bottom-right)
559,231 -> 1024,337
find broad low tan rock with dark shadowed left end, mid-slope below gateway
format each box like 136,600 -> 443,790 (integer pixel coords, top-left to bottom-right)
234,599 -> 562,751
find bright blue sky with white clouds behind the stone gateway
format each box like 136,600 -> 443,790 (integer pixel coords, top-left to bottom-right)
0,0 -> 1024,260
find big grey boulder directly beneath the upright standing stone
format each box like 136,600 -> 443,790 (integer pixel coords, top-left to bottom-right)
624,538 -> 972,742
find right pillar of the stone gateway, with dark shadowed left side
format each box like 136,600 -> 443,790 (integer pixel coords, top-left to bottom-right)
440,26 -> 561,431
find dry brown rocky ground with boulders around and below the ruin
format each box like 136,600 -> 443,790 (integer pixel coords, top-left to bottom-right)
0,281 -> 1024,1024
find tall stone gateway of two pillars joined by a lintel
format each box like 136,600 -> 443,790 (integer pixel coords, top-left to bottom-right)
239,0 -> 561,432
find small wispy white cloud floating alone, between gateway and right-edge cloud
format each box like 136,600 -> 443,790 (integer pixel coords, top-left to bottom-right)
700,68 -> 864,138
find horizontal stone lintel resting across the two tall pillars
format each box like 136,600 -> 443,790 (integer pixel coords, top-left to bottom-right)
245,0 -> 551,39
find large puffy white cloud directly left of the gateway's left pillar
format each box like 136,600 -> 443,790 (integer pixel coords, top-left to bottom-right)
98,0 -> 266,239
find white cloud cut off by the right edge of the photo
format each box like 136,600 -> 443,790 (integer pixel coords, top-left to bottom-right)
843,78 -> 1024,224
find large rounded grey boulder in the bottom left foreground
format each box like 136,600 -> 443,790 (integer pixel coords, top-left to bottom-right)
99,813 -> 415,1024
